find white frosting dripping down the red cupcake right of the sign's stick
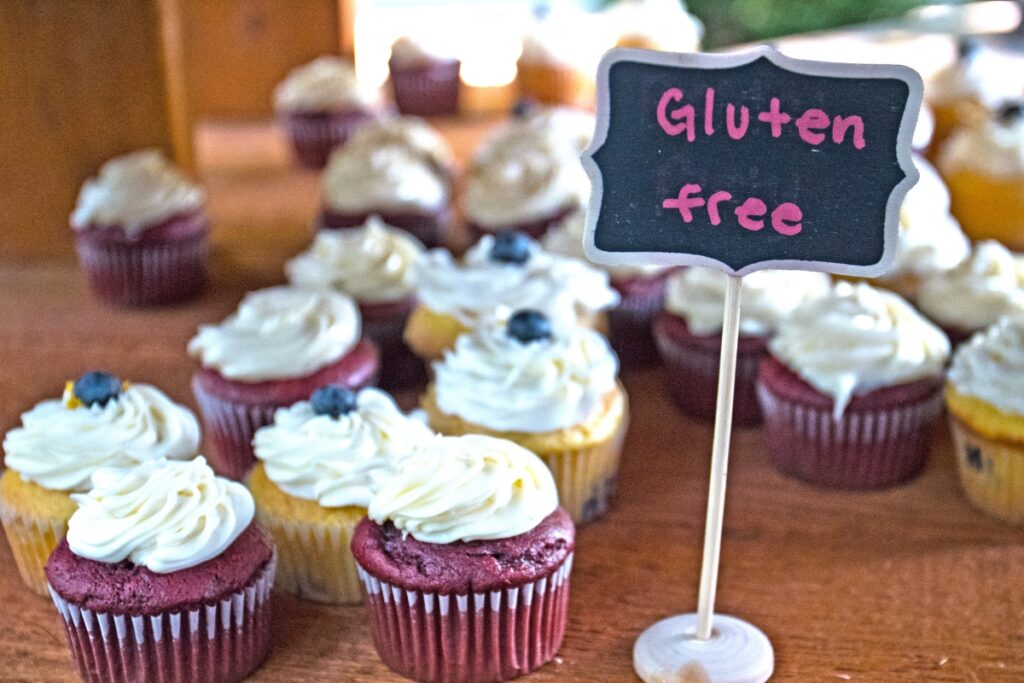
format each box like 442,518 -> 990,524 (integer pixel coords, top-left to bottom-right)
769,283 -> 949,420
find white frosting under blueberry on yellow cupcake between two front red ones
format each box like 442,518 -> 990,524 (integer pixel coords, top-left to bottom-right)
253,388 -> 433,508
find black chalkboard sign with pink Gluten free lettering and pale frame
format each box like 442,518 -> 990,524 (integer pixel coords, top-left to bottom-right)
584,47 -> 922,276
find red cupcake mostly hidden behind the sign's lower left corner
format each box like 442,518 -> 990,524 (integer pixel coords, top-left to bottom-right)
541,210 -> 675,366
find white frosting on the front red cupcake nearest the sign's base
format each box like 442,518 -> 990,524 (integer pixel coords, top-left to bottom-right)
369,434 -> 558,544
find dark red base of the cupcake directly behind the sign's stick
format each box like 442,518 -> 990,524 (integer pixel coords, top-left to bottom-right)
654,311 -> 767,427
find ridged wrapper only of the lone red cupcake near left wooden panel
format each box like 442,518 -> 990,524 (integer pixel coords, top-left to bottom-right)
75,232 -> 207,306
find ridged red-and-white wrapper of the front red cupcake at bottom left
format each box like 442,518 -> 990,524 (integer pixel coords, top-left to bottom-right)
49,559 -> 274,683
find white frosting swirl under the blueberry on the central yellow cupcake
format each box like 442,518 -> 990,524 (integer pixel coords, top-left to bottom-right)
434,322 -> 618,433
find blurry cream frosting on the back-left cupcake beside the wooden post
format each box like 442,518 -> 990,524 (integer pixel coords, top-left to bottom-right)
273,55 -> 380,112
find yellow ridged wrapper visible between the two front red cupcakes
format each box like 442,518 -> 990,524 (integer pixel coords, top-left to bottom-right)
256,508 -> 362,604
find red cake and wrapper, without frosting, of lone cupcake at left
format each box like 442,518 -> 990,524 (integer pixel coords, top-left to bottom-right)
75,213 -> 209,306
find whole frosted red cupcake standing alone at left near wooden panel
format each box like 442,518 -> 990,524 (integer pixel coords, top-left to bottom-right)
71,150 -> 210,306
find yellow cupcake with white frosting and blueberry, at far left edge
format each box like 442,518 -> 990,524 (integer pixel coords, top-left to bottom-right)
0,372 -> 200,595
